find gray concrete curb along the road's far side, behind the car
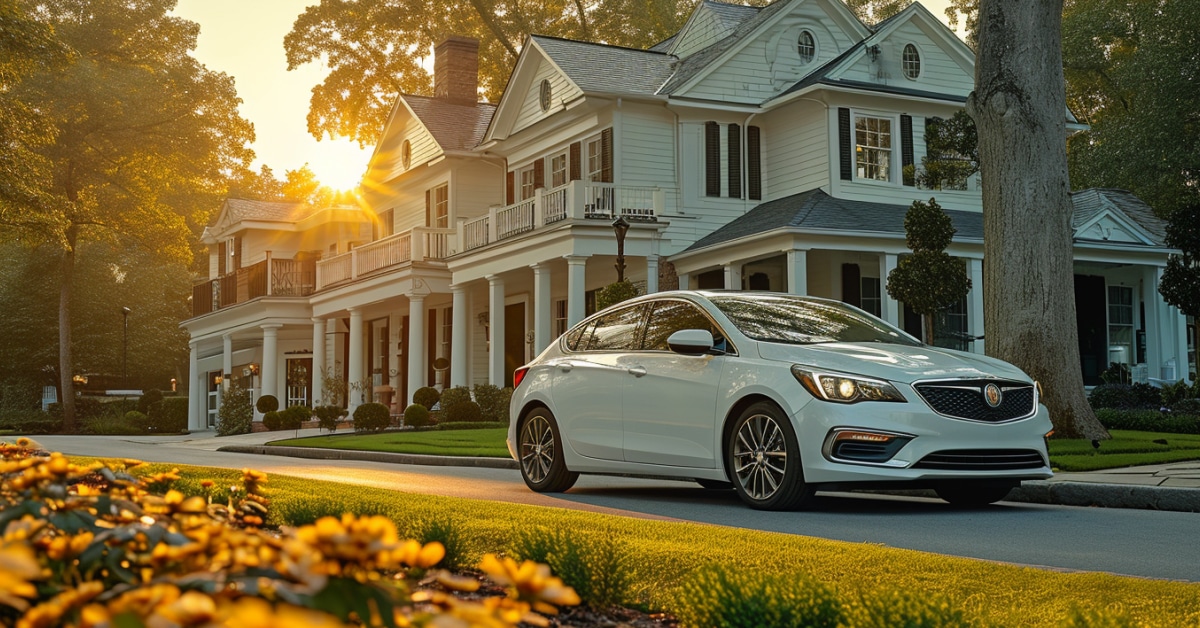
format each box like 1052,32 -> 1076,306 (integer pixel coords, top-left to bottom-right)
217,445 -> 1200,513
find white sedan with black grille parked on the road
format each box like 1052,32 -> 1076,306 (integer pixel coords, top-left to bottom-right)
508,291 -> 1051,510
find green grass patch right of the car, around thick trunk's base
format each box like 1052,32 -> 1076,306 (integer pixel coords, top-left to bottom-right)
1050,430 -> 1200,471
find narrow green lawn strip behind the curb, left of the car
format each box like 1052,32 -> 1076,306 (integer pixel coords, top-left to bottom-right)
269,427 -> 509,457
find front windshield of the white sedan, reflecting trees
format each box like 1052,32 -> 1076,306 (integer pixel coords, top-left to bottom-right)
710,294 -> 920,346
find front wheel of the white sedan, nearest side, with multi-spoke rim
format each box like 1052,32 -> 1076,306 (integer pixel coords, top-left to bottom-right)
725,401 -> 814,510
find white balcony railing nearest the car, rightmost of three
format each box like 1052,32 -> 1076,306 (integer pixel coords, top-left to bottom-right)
458,181 -> 664,251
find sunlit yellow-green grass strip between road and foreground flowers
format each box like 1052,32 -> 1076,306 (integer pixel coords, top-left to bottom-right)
105,465 -> 1200,627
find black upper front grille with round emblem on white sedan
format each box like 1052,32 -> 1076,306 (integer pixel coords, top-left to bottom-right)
913,379 -> 1037,423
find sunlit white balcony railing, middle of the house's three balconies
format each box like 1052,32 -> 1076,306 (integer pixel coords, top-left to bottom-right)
317,227 -> 455,291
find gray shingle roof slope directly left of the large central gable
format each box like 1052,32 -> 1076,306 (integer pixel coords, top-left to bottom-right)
532,35 -> 674,95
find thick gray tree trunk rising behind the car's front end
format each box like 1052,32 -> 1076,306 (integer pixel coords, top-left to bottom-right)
967,0 -> 1109,439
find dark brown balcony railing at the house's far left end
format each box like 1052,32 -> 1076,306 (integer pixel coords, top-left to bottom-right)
192,252 -> 317,316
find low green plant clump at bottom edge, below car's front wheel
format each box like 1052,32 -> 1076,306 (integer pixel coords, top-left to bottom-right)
676,566 -> 844,628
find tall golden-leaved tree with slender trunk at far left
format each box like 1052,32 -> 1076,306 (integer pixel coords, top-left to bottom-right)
0,0 -> 253,430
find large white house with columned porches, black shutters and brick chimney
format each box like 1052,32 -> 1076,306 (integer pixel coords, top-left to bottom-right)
177,0 -> 1188,429
